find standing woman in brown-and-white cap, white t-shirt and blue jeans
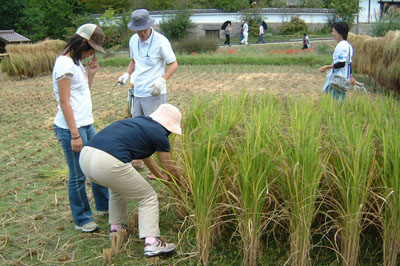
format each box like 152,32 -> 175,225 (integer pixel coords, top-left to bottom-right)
53,24 -> 108,232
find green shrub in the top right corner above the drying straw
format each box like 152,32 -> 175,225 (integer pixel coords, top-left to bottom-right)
372,6 -> 400,37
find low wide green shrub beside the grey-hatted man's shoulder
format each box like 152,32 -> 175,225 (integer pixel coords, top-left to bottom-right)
172,36 -> 218,54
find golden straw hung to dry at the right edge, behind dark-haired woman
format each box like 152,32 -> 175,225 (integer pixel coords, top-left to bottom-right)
349,31 -> 400,91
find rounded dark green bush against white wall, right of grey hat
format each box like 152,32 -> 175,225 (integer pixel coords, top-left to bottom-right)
160,11 -> 195,41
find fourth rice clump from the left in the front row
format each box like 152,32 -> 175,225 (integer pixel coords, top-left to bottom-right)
325,98 -> 375,265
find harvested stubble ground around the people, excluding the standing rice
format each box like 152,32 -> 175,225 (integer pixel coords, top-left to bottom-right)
0,41 -> 388,265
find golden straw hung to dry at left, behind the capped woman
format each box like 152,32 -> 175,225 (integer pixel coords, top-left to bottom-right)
1,40 -> 66,77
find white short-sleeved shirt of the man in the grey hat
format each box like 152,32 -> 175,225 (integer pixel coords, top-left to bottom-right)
129,29 -> 176,97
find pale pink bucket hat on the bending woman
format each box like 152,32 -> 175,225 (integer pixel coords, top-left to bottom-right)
150,103 -> 182,135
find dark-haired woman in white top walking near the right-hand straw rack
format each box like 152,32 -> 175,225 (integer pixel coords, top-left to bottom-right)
319,22 -> 356,100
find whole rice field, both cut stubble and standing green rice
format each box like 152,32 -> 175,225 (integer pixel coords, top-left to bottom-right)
0,40 -> 400,265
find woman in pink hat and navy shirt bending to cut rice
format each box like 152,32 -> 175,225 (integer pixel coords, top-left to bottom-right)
80,104 -> 181,257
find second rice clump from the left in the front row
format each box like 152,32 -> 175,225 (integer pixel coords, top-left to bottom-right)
227,97 -> 280,266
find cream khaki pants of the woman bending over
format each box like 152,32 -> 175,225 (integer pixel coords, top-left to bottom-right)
79,146 -> 160,238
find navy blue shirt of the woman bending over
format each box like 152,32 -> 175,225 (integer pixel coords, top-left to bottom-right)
86,116 -> 170,163
